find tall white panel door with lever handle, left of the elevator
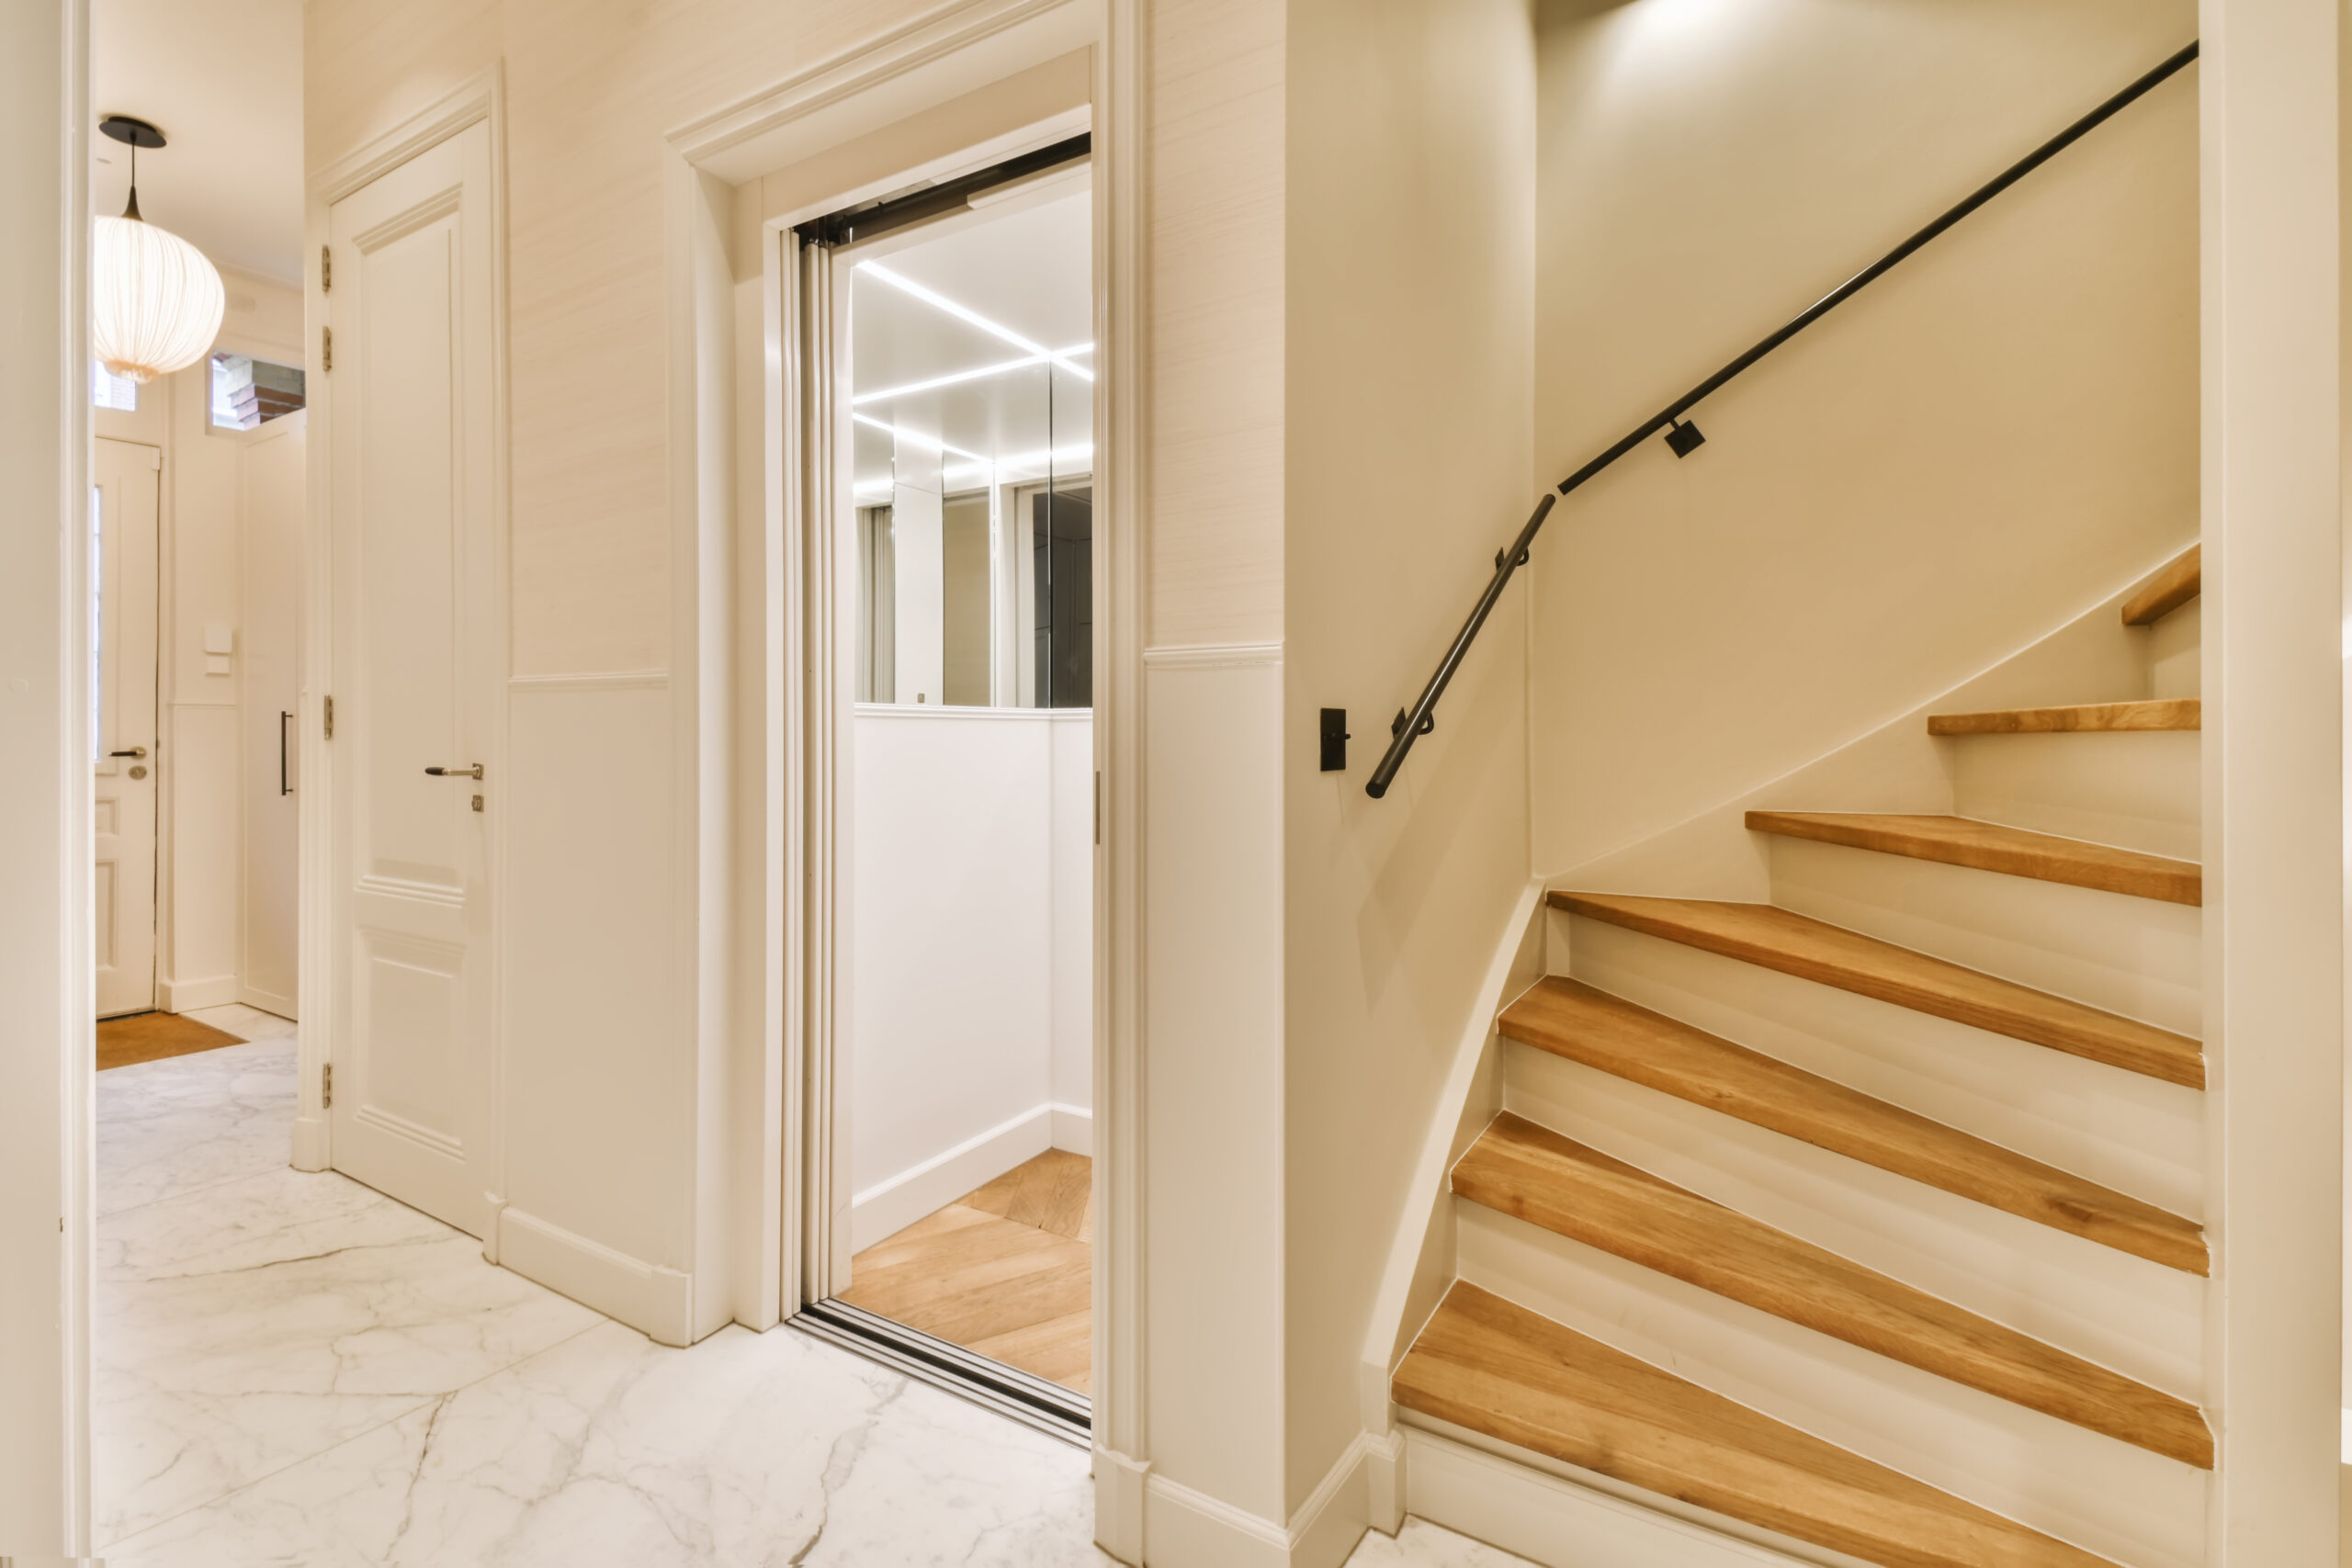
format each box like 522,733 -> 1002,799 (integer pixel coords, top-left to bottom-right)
322,125 -> 505,1236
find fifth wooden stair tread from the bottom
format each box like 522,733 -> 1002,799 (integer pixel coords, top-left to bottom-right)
1747,811 -> 2204,905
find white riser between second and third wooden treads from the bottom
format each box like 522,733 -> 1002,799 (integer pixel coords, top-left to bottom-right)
1503,1043 -> 2206,1399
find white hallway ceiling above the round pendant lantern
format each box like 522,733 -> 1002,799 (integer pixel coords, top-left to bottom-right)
89,0 -> 301,285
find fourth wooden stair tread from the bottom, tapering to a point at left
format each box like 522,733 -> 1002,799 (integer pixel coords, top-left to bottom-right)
1547,891 -> 2204,1089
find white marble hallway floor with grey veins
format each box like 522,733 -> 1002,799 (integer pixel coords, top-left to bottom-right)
92,1009 -> 1520,1568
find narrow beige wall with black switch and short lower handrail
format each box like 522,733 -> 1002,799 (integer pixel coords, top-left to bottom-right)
1282,0 -> 1536,1509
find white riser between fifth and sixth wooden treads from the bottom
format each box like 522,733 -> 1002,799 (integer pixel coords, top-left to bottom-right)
1948,728 -> 2204,861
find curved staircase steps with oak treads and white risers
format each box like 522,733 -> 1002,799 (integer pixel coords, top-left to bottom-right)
1390,550 -> 2213,1568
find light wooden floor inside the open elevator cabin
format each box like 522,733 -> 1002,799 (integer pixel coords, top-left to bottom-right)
840,1149 -> 1093,1394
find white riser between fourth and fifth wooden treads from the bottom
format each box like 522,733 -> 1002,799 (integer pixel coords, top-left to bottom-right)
1771,837 -> 2204,1037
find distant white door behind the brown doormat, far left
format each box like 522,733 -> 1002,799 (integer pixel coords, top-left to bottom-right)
89,440 -> 163,1018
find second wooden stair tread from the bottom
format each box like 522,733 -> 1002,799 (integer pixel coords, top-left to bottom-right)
1453,1112 -> 2213,1470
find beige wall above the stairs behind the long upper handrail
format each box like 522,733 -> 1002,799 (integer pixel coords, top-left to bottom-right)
1533,0 -> 2197,872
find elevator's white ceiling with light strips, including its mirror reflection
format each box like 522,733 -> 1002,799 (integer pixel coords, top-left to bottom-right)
849,188 -> 1093,499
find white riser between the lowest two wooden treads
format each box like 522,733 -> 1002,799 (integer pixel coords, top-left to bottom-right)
1456,1201 -> 2206,1568
